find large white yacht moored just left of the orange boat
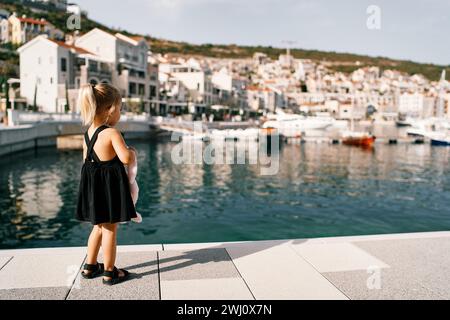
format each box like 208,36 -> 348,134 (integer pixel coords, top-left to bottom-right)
262,111 -> 335,138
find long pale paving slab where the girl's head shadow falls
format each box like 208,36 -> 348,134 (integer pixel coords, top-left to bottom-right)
227,242 -> 347,300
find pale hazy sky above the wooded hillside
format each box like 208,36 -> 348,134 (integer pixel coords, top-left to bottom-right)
74,0 -> 450,65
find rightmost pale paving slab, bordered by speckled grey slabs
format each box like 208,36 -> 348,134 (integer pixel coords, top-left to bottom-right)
292,242 -> 389,272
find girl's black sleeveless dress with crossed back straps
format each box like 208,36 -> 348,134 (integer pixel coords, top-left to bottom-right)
76,125 -> 137,225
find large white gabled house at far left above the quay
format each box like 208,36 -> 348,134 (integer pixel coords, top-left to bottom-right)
17,35 -> 113,112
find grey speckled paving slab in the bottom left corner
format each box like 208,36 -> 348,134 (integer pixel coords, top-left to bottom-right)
0,287 -> 69,300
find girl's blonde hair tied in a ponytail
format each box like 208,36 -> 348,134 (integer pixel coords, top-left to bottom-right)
77,83 -> 122,125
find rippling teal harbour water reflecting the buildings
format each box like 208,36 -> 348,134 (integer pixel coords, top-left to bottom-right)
0,139 -> 450,249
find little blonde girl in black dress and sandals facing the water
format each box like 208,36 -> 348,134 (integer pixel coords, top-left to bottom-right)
76,83 -> 137,285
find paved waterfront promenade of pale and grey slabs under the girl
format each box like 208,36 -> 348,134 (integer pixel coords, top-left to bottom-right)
0,232 -> 450,300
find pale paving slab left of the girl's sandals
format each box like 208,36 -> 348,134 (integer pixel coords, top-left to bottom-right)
0,252 -> 85,289
